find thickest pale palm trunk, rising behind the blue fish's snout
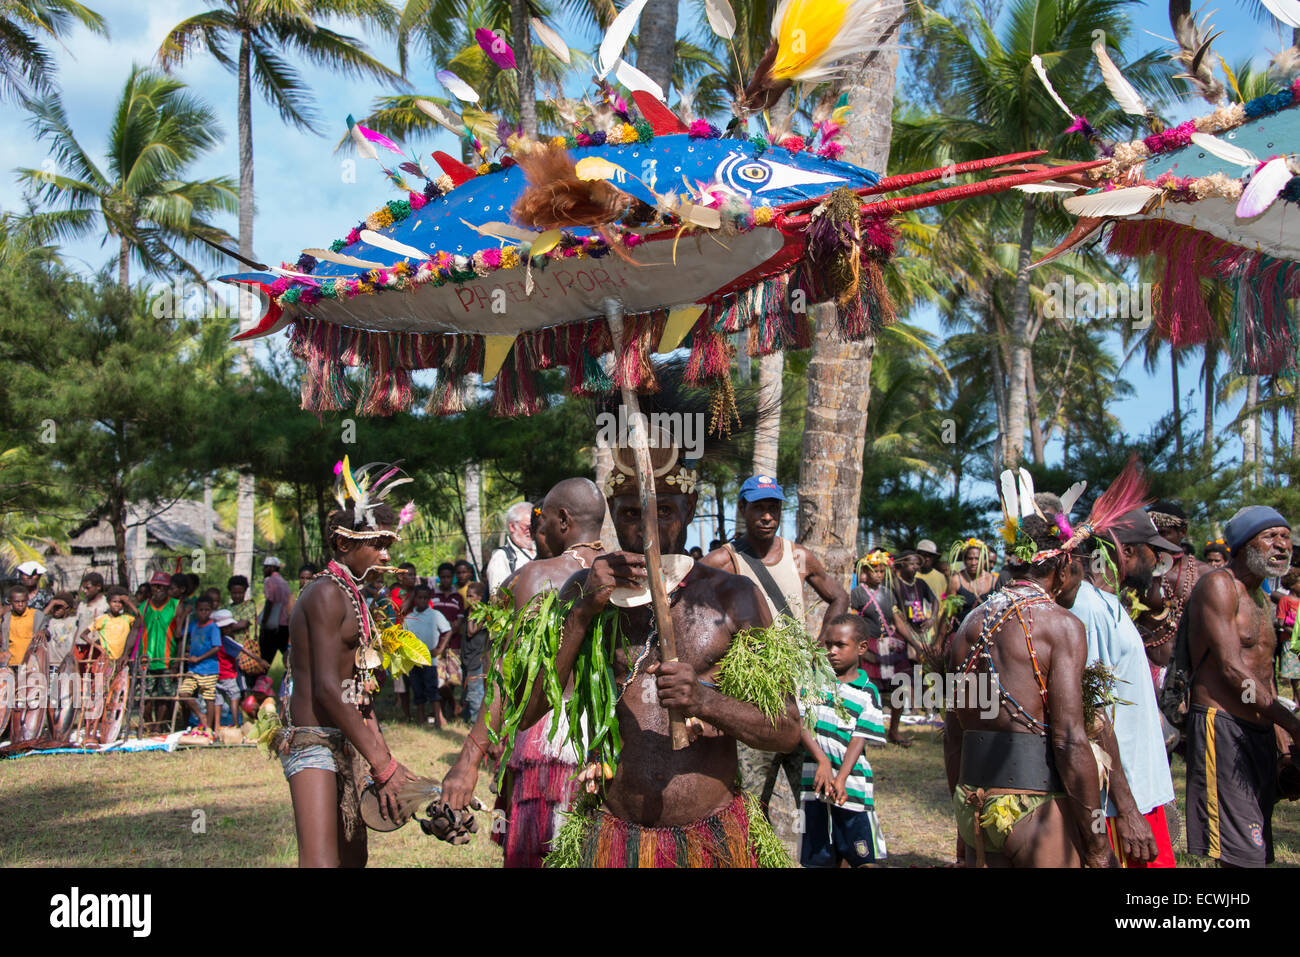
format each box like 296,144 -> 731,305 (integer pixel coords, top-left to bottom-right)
797,20 -> 900,635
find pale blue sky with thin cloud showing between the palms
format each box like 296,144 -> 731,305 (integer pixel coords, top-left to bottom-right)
0,0 -> 1290,530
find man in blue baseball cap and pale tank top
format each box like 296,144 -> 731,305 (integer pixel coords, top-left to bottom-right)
702,475 -> 849,853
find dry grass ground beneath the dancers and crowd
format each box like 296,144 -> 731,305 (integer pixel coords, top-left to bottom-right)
0,722 -> 1300,867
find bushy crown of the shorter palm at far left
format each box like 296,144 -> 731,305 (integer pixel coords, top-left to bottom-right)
18,66 -> 238,289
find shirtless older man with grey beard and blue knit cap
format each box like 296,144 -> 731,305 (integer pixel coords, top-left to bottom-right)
1186,505 -> 1300,867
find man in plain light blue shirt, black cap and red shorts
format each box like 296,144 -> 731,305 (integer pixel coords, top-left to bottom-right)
1070,508 -> 1180,867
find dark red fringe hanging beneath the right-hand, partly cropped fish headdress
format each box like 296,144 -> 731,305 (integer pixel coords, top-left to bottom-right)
1108,220 -> 1300,376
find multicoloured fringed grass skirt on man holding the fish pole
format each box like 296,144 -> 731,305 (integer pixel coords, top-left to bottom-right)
546,793 -> 789,867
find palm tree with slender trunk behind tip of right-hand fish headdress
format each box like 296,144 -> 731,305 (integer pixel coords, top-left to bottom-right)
917,0 -> 1169,464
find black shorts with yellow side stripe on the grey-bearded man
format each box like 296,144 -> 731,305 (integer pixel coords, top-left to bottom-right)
1187,705 -> 1278,867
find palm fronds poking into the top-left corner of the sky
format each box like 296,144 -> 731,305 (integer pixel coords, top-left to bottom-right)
0,0 -> 108,101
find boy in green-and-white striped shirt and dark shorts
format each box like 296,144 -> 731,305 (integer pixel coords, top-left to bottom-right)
800,615 -> 885,867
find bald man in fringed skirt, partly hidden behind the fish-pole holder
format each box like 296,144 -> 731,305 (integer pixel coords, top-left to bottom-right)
442,479 -> 606,867
